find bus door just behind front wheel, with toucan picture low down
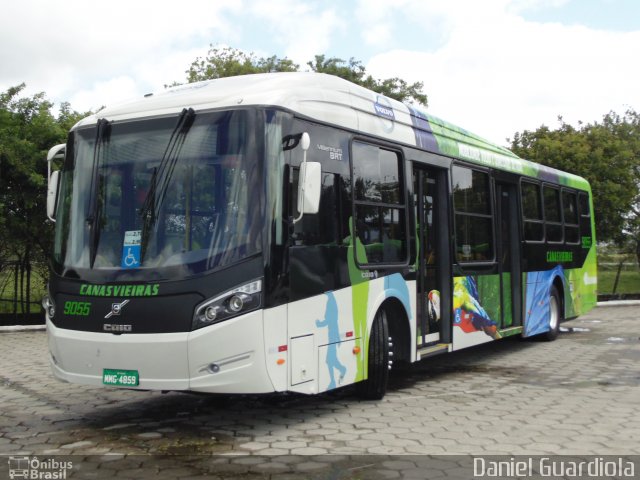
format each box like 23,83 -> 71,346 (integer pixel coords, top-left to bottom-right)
413,164 -> 451,349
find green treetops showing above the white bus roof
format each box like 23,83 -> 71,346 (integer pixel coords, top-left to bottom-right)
178,46 -> 427,107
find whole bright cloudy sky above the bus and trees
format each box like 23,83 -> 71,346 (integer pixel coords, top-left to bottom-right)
0,0 -> 640,145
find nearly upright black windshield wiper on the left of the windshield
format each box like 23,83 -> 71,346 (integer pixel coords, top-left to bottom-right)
87,118 -> 111,268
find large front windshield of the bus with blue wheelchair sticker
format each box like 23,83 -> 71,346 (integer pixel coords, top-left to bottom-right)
53,111 -> 263,281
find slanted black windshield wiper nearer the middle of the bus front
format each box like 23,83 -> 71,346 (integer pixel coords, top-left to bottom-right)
140,108 -> 196,261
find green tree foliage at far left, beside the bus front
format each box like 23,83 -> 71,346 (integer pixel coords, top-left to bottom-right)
0,84 -> 85,316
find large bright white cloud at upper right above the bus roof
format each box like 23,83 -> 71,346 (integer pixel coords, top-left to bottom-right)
367,0 -> 640,144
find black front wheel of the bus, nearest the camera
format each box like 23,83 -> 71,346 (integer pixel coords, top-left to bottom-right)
357,309 -> 391,400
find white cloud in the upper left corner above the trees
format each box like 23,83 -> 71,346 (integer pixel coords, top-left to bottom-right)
0,0 -> 242,110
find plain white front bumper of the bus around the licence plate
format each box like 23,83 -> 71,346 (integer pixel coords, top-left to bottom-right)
47,311 -> 274,393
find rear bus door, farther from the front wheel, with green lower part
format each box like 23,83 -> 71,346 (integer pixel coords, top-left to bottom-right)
495,181 -> 522,329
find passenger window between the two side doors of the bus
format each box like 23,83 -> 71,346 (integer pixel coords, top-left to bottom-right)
451,165 -> 494,263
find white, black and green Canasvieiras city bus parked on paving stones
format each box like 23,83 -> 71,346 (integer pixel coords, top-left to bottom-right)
43,72 -> 597,399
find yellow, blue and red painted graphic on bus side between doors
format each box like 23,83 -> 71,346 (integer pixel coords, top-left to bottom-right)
453,276 -> 502,339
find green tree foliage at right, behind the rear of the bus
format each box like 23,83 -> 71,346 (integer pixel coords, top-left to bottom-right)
511,110 -> 640,257
